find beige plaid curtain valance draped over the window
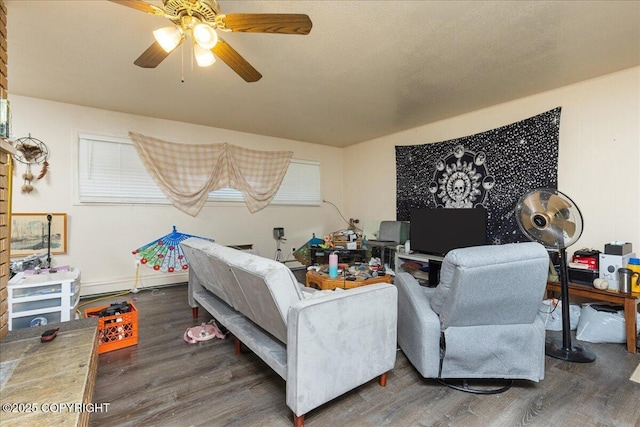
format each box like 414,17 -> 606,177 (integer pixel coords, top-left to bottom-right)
129,132 -> 293,216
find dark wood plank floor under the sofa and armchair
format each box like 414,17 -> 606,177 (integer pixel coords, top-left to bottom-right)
85,285 -> 640,427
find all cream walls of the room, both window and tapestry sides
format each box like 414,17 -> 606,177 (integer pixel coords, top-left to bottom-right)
9,67 -> 640,295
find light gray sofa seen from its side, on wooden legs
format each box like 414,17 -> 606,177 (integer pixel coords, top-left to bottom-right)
181,238 -> 397,426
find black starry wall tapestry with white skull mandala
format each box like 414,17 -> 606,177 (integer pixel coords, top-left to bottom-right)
396,107 -> 561,244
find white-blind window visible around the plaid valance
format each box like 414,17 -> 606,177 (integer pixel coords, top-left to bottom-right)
78,134 -> 322,206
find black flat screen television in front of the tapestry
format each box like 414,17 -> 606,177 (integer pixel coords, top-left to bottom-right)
409,208 -> 487,256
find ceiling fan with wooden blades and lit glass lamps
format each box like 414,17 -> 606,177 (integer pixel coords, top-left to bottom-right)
109,0 -> 312,82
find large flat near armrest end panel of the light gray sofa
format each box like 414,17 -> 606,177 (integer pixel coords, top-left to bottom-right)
287,284 -> 398,415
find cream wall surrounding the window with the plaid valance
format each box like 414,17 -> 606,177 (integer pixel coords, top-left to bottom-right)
9,96 -> 346,295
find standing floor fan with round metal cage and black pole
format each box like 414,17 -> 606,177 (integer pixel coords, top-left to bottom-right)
515,188 -> 596,363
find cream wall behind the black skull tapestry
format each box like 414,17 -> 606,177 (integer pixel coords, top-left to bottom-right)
343,67 -> 640,254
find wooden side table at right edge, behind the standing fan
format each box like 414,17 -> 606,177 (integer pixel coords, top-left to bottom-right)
547,282 -> 640,353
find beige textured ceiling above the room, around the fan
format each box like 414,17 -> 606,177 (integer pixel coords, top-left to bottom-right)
5,0 -> 640,147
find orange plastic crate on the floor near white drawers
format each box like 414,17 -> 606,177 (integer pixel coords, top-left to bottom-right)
84,301 -> 138,354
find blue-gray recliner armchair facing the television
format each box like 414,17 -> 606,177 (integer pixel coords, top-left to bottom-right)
394,242 -> 549,390
